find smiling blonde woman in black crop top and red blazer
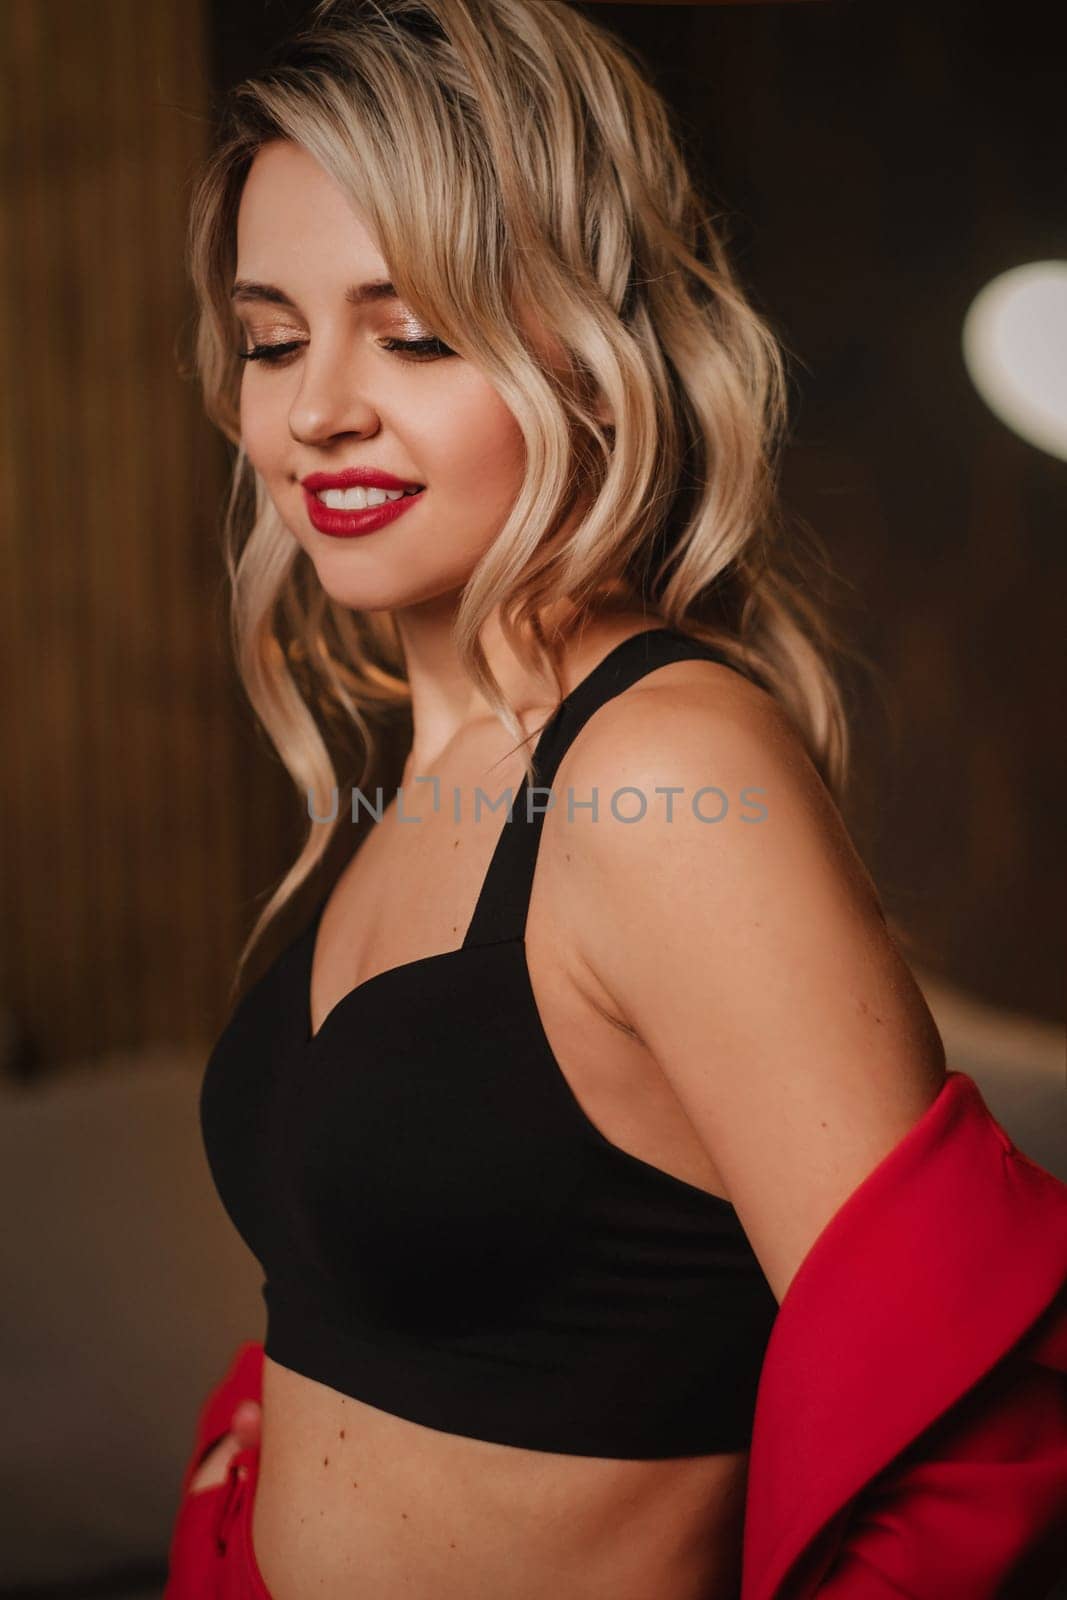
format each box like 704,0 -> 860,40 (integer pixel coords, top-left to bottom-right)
168,0 -> 1067,1600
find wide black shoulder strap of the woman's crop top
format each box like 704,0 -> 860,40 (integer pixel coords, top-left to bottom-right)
464,627 -> 751,947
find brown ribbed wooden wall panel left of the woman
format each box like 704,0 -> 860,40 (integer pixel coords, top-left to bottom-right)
0,0 -> 296,1062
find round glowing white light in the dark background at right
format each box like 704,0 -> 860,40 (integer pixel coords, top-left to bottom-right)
963,261 -> 1067,461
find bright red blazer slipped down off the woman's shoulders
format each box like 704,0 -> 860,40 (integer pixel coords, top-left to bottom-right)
182,1072 -> 1067,1600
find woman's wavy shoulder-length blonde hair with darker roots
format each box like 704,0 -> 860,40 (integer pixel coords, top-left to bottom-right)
189,0 -> 848,971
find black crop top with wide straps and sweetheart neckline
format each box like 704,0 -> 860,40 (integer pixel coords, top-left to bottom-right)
200,629 -> 777,1459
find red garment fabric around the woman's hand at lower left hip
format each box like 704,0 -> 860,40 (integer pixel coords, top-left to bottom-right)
163,1339 -> 270,1600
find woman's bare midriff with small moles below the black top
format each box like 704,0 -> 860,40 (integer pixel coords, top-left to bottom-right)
251,1360 -> 749,1600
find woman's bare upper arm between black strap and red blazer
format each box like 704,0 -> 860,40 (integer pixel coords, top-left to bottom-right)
566,683 -> 945,1302
